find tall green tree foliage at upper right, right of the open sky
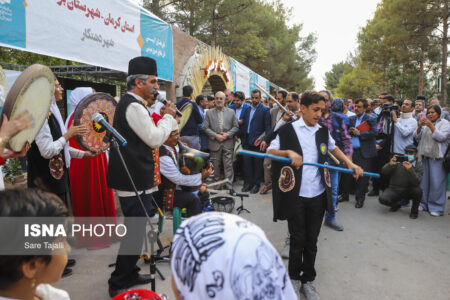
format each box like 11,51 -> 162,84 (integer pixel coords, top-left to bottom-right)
329,0 -> 448,102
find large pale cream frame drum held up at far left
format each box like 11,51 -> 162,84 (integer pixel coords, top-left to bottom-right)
2,64 -> 56,152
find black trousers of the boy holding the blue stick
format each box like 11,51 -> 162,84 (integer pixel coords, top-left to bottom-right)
287,193 -> 327,283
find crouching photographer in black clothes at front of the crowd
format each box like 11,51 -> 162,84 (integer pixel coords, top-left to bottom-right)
379,144 -> 423,219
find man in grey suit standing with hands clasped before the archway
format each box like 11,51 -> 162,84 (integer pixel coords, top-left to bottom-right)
204,92 -> 239,193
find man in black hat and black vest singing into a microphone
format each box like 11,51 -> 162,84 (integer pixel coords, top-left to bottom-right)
108,56 -> 178,297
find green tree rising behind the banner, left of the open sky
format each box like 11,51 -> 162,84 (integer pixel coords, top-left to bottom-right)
148,0 -> 316,90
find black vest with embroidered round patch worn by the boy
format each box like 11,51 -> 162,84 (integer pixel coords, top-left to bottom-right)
272,123 -> 334,221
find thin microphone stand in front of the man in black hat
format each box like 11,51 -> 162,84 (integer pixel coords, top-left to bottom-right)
103,132 -> 165,292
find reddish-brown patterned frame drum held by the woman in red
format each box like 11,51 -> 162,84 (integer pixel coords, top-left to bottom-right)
73,93 -> 116,152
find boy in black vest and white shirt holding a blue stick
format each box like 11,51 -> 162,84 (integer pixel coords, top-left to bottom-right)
268,91 -> 363,299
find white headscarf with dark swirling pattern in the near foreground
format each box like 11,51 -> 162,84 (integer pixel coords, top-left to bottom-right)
171,212 -> 297,300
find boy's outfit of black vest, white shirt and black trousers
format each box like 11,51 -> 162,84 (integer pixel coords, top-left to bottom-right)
268,118 -> 335,283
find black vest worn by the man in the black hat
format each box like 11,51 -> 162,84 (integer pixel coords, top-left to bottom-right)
108,94 -> 159,191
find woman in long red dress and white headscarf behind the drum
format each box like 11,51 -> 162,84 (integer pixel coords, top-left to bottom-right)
67,87 -> 116,249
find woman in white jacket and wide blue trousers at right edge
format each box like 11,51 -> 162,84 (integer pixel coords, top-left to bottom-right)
414,105 -> 450,217
